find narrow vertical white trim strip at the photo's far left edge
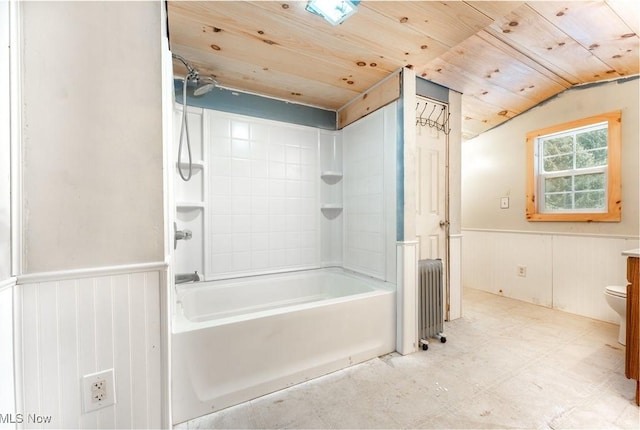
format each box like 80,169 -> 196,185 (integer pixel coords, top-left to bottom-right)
9,0 -> 24,276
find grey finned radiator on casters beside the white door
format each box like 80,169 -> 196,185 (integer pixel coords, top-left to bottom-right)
418,259 -> 447,350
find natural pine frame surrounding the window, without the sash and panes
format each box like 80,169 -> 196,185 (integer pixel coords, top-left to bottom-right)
526,111 -> 622,222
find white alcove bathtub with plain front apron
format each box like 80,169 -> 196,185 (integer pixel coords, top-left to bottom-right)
171,269 -> 396,424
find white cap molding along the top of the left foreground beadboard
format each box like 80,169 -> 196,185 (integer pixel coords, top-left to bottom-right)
16,261 -> 169,285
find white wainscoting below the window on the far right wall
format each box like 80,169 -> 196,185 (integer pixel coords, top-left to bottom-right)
462,229 -> 640,323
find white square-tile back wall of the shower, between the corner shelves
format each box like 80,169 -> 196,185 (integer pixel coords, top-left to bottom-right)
205,111 -> 320,278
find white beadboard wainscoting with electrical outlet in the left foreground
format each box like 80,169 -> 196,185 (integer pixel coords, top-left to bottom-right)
14,263 -> 167,428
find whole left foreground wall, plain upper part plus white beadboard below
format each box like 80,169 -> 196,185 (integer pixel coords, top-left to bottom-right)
13,2 -> 168,428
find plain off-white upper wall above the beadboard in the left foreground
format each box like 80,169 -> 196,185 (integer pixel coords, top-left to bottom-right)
21,2 -> 164,273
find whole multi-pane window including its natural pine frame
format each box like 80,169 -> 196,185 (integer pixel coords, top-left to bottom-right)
526,111 -> 621,221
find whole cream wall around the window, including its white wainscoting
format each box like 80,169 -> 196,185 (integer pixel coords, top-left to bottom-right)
462,79 -> 640,322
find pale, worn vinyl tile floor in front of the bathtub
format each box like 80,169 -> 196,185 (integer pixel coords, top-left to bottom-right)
175,289 -> 640,429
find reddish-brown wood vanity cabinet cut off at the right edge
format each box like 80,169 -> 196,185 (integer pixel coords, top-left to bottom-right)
624,257 -> 640,406
